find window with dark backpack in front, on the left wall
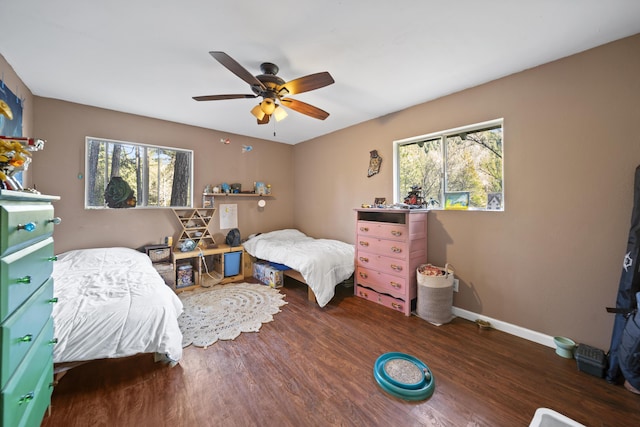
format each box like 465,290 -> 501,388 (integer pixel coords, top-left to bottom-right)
85,137 -> 193,209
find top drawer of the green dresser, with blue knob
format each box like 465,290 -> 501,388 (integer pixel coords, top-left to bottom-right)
0,202 -> 54,256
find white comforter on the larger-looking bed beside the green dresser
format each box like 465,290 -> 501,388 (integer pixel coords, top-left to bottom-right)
53,248 -> 183,363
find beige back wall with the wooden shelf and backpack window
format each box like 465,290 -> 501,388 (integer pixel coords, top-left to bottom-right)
33,97 -> 293,252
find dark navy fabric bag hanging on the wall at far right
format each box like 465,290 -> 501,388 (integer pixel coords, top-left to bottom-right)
606,166 -> 640,383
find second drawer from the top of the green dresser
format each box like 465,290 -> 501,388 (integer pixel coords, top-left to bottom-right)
0,237 -> 55,322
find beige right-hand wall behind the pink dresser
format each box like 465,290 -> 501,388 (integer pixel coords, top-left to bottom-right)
294,31 -> 640,349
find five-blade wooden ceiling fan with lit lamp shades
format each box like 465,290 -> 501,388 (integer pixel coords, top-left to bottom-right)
193,52 -> 334,125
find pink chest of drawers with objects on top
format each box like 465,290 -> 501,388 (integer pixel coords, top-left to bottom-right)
355,209 -> 428,316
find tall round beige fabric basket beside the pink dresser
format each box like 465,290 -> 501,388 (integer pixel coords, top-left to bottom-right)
416,264 -> 454,325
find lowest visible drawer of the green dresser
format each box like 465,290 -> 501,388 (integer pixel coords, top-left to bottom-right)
0,319 -> 53,426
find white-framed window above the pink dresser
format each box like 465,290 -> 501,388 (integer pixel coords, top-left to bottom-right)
393,119 -> 504,210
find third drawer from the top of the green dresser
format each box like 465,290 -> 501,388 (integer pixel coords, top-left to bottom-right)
0,278 -> 54,388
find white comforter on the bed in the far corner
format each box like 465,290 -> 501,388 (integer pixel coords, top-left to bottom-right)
242,229 -> 355,307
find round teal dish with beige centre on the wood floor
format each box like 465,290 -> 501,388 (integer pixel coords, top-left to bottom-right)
373,352 -> 436,400
